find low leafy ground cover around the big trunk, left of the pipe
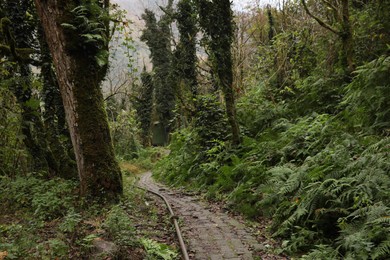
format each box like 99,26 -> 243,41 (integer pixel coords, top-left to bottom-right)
0,171 -> 177,259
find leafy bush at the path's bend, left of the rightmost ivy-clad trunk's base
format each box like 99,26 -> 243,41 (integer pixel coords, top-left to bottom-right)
156,96 -> 227,185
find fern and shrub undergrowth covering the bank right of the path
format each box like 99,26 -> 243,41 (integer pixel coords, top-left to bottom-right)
155,54 -> 390,259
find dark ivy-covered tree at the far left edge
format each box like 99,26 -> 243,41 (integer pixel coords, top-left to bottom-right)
0,0 -> 60,176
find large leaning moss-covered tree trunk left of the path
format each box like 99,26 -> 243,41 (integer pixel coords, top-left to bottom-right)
35,0 -> 122,199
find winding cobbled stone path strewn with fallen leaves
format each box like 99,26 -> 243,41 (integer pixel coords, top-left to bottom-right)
139,172 -> 285,260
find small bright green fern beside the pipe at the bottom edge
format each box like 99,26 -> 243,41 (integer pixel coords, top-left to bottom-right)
141,238 -> 178,260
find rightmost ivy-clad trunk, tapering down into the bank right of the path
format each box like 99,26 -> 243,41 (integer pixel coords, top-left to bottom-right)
197,0 -> 241,145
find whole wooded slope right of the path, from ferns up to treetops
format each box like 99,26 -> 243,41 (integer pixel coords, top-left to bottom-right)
152,1 -> 390,259
